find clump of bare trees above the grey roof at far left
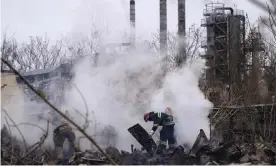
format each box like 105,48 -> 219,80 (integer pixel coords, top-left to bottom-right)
1,37 -> 68,71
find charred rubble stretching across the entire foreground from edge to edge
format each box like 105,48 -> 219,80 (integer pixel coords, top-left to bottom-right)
1,127 -> 276,165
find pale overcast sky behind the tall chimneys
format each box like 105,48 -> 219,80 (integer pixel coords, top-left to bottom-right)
1,0 -> 264,40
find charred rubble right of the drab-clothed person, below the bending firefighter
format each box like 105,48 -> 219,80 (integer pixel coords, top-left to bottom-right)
69,130 -> 276,165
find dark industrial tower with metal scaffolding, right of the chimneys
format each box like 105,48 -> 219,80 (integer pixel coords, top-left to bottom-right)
201,2 -> 268,103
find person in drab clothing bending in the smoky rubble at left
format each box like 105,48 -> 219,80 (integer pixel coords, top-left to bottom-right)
54,118 -> 80,164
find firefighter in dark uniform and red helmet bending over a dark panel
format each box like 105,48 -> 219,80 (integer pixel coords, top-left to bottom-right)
144,107 -> 176,152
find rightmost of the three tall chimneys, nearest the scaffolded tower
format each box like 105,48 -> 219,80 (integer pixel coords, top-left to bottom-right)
177,0 -> 186,66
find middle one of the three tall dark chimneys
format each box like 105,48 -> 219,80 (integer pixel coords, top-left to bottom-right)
159,0 -> 167,54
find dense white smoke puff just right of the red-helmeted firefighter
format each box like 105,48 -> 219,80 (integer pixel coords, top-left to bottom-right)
152,59 -> 212,146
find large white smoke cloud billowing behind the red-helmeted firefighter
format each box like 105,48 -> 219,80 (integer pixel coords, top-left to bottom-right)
61,38 -> 212,150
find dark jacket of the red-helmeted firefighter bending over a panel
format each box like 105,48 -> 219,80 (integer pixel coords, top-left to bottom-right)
150,112 -> 175,131
